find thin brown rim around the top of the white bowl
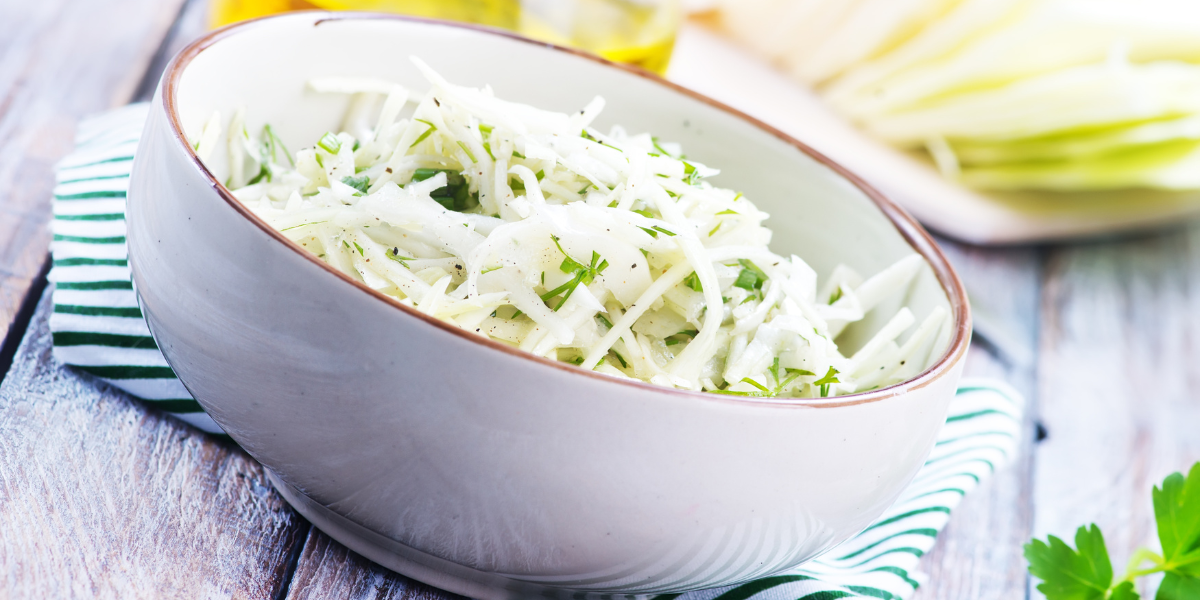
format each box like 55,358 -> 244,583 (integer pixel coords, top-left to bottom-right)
160,11 -> 971,408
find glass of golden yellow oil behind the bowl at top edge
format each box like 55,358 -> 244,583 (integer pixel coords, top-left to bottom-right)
211,0 -> 680,74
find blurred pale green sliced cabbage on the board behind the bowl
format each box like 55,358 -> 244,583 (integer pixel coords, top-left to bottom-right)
721,0 -> 1200,191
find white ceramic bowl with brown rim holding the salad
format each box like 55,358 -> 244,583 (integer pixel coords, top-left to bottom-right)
128,13 -> 970,599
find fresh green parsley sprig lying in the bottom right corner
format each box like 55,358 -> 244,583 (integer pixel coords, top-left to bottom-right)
1025,463 -> 1200,600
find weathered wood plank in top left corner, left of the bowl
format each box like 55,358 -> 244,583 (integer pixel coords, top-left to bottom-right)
0,0 -> 182,338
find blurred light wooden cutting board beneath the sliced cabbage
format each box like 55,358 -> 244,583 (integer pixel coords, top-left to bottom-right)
667,22 -> 1200,245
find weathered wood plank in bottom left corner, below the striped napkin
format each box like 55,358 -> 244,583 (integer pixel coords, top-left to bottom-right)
0,295 -> 308,599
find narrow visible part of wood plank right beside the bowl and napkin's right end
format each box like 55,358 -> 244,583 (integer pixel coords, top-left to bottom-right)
916,240 -> 1042,600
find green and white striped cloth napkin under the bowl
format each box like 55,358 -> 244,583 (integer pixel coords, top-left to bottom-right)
50,104 -> 1024,600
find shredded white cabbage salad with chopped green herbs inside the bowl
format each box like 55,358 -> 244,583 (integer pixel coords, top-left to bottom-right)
193,59 -> 948,397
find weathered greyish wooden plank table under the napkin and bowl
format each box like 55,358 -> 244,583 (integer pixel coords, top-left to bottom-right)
0,0 -> 1200,600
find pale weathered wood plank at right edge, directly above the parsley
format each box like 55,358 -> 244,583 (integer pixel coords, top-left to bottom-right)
1033,223 -> 1200,598
